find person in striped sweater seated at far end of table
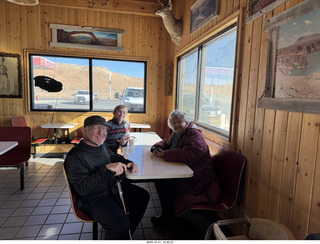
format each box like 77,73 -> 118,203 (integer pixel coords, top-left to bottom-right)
106,105 -> 130,153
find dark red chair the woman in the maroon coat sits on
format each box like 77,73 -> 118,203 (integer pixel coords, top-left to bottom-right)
190,147 -> 245,211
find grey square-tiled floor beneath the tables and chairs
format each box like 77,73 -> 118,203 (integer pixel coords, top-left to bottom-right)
0,159 -> 176,240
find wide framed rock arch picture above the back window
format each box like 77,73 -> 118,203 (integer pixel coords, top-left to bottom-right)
50,24 -> 125,51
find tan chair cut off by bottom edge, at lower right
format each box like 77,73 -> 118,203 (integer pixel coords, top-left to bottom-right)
205,218 -> 295,240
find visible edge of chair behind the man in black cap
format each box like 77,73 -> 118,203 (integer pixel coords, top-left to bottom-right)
62,163 -> 98,240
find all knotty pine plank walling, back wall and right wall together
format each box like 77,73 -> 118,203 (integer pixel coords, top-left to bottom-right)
0,0 -> 320,239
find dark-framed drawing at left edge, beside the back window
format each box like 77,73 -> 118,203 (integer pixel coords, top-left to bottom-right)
0,53 -> 22,98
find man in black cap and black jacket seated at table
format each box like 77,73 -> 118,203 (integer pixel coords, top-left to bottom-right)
64,116 -> 150,240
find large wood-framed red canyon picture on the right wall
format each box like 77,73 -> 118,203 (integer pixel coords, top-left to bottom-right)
258,0 -> 320,114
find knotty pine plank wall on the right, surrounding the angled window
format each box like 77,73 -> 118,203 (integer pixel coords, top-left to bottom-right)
175,0 -> 320,239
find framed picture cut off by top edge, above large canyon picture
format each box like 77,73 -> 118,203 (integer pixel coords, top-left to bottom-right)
246,0 -> 287,23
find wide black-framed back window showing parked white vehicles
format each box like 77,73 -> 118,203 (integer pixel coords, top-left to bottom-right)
29,54 -> 146,113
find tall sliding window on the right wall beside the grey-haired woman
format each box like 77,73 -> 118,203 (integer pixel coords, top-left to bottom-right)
177,25 -> 237,136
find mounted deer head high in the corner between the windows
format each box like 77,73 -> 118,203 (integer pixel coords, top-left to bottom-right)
155,0 -> 183,45
